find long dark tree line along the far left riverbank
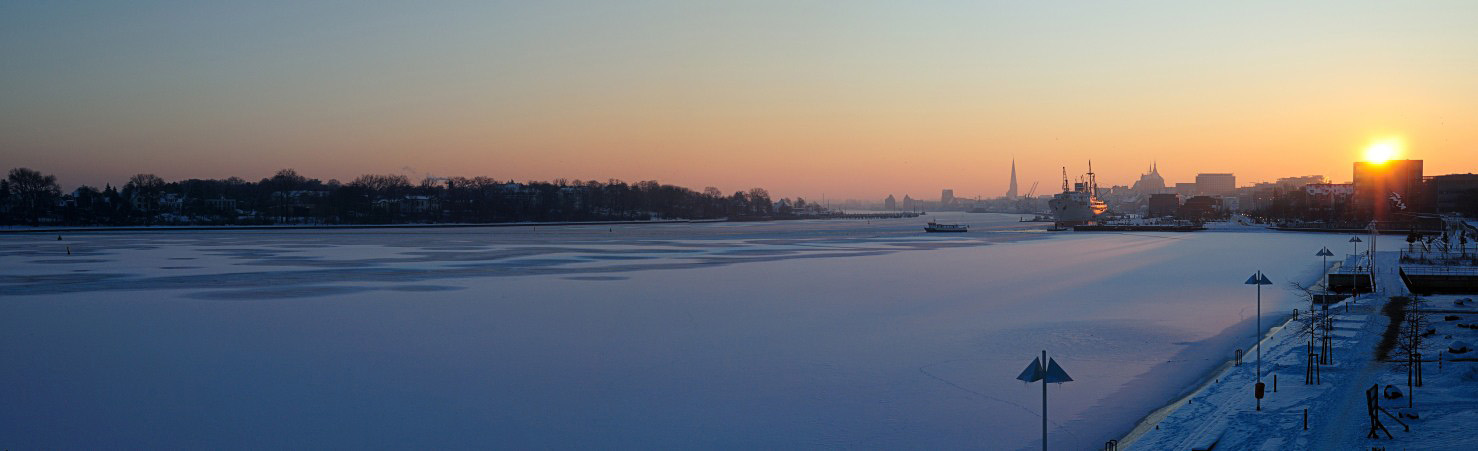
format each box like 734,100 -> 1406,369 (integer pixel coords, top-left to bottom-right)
0,167 -> 806,226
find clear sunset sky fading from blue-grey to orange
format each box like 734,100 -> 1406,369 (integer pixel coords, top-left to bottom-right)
0,0 -> 1478,200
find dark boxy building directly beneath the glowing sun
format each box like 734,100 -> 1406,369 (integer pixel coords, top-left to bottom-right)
1352,160 -> 1422,220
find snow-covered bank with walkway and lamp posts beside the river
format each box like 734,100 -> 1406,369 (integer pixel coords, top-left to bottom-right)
1123,246 -> 1478,450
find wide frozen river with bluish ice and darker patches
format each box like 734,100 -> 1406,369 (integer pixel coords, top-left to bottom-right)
0,213 -> 1351,450
